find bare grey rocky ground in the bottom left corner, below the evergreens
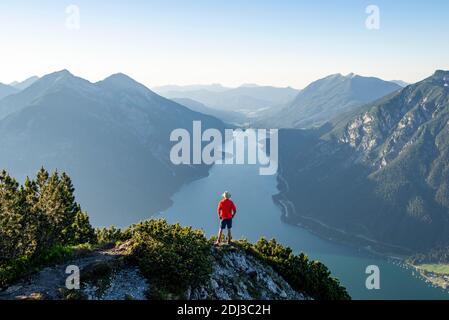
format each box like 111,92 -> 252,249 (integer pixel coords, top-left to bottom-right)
0,248 -> 149,300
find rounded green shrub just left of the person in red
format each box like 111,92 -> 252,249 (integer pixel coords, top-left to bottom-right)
130,220 -> 212,298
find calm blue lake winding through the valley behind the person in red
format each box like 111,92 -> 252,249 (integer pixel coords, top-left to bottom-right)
163,132 -> 449,299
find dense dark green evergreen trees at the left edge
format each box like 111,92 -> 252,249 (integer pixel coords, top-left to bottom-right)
0,168 -> 95,287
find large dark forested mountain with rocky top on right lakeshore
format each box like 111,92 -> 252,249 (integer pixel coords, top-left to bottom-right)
279,71 -> 449,251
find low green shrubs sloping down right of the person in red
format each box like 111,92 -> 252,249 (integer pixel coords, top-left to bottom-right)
237,238 -> 351,300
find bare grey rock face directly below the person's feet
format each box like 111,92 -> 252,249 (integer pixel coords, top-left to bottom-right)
186,248 -> 305,300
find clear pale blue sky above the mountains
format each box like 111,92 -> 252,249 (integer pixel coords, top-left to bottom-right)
0,0 -> 449,88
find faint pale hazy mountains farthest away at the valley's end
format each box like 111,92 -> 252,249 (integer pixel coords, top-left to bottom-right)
153,85 -> 298,115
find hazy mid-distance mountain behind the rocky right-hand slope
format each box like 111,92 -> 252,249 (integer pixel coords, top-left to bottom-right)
257,73 -> 401,128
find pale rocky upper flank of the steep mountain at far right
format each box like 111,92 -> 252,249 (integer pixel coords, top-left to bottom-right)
339,71 -> 449,168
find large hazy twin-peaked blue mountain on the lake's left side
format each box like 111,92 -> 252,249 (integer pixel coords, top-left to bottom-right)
0,70 -> 224,226
